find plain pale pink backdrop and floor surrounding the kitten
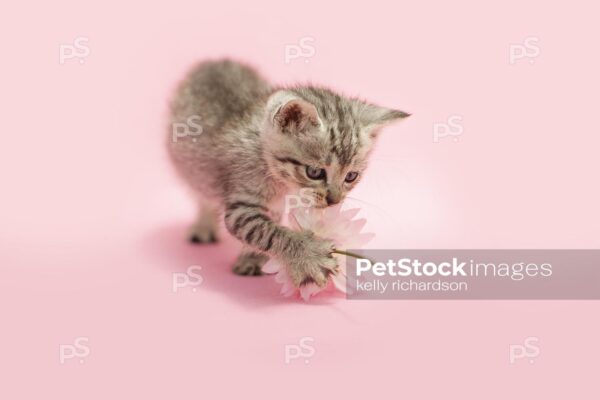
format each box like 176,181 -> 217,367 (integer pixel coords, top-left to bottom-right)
0,0 -> 600,399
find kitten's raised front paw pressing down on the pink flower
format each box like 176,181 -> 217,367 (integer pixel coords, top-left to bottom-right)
288,233 -> 337,287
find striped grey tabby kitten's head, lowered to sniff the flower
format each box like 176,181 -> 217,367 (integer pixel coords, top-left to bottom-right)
263,87 -> 409,207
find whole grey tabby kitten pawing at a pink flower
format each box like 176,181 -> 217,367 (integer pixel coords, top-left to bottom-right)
168,60 -> 408,287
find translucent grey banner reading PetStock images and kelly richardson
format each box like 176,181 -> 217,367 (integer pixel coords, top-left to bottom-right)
346,249 -> 600,300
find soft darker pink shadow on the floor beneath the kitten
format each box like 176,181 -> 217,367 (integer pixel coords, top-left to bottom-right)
142,224 -> 340,309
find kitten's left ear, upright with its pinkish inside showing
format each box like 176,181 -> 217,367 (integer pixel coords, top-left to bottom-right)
267,90 -> 321,133
